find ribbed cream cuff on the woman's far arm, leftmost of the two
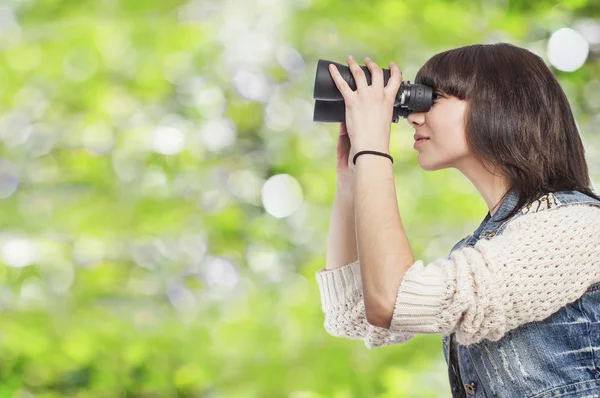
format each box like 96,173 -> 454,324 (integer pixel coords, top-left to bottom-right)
315,260 -> 362,313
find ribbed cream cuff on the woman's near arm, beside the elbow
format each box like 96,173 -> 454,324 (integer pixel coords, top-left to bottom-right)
390,260 -> 451,334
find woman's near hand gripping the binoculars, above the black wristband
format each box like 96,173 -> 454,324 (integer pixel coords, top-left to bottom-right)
329,56 -> 402,153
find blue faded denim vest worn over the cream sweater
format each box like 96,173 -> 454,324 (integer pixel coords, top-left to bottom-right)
442,190 -> 600,398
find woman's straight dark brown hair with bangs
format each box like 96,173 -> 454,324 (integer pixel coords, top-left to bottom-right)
415,43 -> 600,221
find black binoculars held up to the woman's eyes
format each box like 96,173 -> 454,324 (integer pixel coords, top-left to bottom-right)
313,59 -> 434,123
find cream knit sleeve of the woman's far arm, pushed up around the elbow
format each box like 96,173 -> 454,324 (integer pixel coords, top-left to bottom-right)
316,261 -> 414,349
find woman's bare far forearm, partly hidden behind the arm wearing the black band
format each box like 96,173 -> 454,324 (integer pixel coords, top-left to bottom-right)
325,176 -> 358,269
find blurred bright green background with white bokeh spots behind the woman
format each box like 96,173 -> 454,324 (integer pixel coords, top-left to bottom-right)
0,0 -> 600,398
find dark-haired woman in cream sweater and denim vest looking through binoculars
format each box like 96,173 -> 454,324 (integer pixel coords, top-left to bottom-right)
316,43 -> 600,398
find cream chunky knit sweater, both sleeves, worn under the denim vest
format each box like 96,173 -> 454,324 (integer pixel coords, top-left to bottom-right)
316,205 -> 600,349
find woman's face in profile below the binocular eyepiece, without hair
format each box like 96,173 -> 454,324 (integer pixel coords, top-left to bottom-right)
407,90 -> 470,171
